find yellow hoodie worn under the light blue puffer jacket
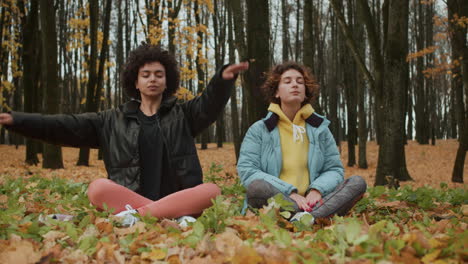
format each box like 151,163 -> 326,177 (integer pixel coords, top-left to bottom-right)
268,103 -> 314,195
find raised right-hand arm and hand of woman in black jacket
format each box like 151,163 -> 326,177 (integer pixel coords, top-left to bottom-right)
182,62 -> 249,137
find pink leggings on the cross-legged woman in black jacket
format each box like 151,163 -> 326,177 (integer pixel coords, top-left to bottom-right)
88,179 -> 221,218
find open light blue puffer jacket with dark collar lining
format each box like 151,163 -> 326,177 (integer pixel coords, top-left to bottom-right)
237,109 -> 344,197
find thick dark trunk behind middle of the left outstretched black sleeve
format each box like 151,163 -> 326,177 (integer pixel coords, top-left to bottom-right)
39,0 -> 63,169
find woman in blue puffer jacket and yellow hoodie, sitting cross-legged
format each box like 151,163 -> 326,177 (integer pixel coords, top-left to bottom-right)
237,62 -> 367,223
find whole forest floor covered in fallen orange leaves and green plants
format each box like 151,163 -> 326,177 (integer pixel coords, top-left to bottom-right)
0,140 -> 468,263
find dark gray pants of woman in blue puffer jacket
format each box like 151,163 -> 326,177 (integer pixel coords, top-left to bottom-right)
247,176 -> 367,218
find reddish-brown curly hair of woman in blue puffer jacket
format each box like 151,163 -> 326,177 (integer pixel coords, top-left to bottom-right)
261,61 -> 319,105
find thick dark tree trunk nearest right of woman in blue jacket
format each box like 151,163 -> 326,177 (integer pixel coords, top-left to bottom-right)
375,0 -> 411,185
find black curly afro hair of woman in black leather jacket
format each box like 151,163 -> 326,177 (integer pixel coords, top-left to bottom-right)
122,43 -> 180,99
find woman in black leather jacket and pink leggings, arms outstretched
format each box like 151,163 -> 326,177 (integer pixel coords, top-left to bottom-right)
0,44 -> 248,226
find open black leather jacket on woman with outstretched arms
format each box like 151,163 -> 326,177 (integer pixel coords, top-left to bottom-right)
7,67 -> 235,193
